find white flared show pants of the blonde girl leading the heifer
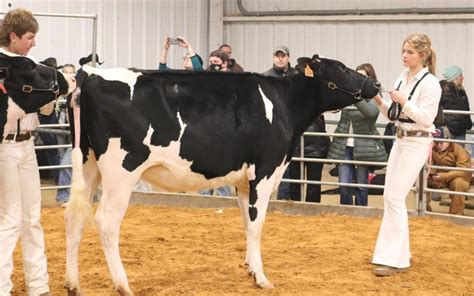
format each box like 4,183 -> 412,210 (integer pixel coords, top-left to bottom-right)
372,137 -> 432,268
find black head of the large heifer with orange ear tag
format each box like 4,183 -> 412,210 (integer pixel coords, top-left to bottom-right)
296,55 -> 380,110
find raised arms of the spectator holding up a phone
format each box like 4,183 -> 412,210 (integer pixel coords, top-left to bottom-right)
158,36 -> 203,71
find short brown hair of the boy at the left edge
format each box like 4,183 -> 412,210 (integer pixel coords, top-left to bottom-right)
0,8 -> 39,46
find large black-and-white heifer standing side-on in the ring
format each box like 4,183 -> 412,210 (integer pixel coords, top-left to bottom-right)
65,56 -> 378,295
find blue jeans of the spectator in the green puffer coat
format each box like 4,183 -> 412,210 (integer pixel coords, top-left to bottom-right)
338,146 -> 369,206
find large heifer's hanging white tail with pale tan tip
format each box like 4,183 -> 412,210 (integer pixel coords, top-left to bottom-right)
65,78 -> 94,224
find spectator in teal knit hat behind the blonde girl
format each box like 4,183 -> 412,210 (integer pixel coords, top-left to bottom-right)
440,65 -> 472,147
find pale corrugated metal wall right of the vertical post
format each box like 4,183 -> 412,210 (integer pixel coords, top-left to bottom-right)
223,0 -> 474,122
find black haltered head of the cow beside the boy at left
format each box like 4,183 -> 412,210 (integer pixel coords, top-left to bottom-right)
0,54 -> 75,113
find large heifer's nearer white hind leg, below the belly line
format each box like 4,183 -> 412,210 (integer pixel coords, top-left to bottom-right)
95,184 -> 138,296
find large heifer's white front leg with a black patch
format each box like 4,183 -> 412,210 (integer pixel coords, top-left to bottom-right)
247,180 -> 273,289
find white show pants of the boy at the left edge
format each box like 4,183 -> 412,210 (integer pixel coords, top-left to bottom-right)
0,138 -> 49,296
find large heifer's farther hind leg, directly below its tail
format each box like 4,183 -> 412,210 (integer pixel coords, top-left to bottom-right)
64,150 -> 100,295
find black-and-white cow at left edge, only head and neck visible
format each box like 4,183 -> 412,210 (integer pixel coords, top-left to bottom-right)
0,53 -> 76,142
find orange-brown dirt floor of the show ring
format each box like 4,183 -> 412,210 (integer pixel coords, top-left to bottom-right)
13,206 -> 474,295
